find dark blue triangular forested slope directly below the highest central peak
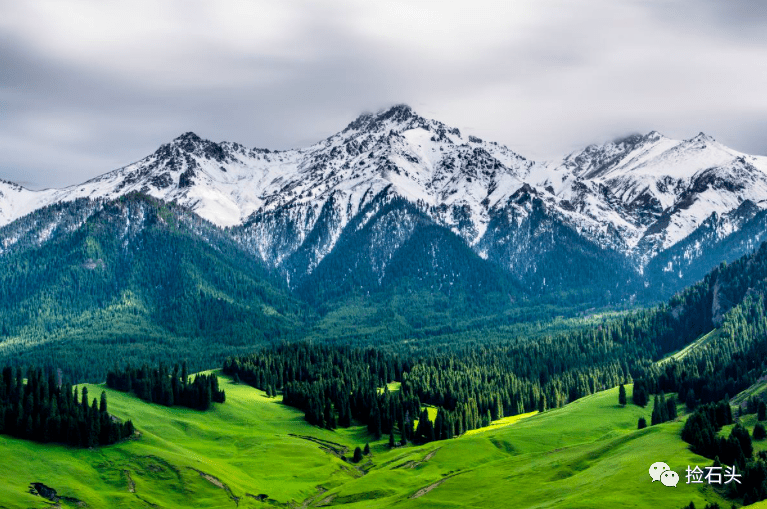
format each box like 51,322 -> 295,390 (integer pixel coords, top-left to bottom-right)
288,192 -> 521,308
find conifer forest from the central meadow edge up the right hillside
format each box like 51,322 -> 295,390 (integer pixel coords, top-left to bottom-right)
224,246 -> 767,450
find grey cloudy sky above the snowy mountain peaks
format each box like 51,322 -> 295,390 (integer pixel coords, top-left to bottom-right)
0,0 -> 767,188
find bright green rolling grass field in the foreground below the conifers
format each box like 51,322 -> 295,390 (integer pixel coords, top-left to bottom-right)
0,378 -> 730,509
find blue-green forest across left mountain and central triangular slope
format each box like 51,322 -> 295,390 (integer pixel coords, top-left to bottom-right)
0,193 -> 632,382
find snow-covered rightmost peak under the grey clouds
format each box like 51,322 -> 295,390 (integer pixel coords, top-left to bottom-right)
525,131 -> 767,265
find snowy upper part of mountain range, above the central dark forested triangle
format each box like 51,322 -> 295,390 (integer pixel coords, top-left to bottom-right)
0,105 -> 767,300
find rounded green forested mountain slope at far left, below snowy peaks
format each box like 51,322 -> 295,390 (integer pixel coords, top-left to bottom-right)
0,195 -> 306,379
